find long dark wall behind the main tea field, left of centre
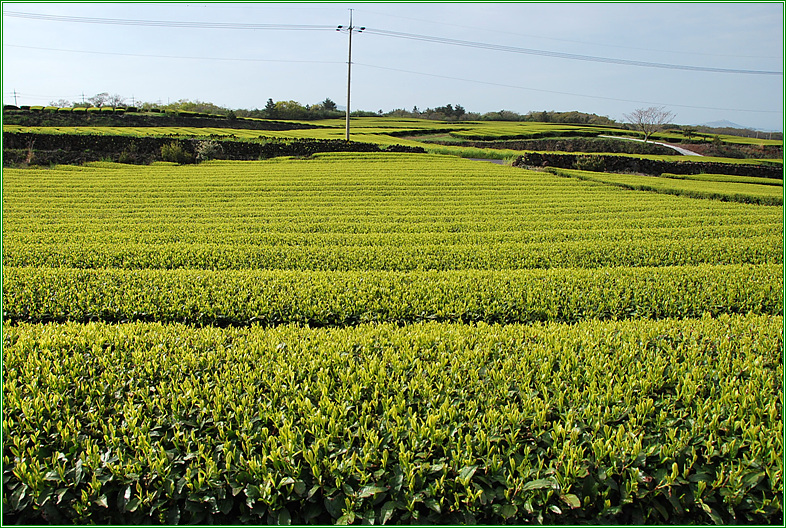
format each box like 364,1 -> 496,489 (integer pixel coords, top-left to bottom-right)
3,132 -> 425,166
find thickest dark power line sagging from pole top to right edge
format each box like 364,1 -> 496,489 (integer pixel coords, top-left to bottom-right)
366,28 -> 783,75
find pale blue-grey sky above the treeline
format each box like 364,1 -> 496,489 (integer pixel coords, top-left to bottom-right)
2,2 -> 784,131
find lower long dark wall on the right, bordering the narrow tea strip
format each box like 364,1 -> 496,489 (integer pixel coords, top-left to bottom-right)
513,152 -> 783,180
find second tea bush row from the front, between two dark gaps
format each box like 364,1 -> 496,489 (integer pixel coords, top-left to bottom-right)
3,265 -> 783,326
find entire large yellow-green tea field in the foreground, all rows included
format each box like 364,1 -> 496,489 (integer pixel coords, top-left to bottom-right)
2,153 -> 783,524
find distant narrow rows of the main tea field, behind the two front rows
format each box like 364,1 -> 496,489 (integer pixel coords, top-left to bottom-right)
3,157 -> 783,271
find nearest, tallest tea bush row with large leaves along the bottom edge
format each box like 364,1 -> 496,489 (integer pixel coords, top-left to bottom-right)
3,315 -> 783,524
